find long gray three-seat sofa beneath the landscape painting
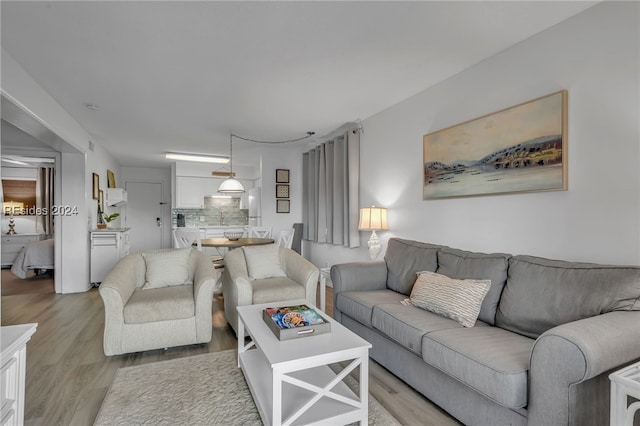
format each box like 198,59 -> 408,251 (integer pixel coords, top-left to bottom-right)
331,238 -> 640,425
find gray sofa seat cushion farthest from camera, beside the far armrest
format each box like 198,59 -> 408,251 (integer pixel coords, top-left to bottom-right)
335,290 -> 404,327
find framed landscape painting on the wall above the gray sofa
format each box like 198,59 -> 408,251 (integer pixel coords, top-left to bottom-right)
422,90 -> 567,200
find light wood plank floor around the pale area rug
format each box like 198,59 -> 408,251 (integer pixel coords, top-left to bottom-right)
1,271 -> 459,426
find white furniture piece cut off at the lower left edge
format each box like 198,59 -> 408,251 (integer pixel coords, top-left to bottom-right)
0,324 -> 38,426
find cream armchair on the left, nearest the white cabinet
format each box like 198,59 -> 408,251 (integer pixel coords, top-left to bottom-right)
99,249 -> 220,355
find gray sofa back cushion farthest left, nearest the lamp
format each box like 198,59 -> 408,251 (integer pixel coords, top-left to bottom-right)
384,238 -> 444,295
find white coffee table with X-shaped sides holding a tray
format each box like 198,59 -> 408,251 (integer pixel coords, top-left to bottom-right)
238,300 -> 371,426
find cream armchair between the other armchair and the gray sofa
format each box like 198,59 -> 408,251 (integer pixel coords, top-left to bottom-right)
222,244 -> 320,334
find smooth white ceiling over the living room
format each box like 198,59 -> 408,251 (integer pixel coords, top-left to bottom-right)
0,0 -> 596,166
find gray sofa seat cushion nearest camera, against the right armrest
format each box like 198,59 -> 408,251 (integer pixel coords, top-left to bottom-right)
422,327 -> 534,409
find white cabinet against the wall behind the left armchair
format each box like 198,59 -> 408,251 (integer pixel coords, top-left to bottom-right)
91,228 -> 129,284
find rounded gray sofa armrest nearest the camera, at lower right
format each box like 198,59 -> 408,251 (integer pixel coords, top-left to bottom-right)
529,311 -> 640,424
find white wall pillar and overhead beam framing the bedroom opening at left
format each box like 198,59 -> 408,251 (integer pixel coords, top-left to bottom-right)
0,49 -> 116,293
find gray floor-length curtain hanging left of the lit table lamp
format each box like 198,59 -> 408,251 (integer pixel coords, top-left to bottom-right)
302,130 -> 360,248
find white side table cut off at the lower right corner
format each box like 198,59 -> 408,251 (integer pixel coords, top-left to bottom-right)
609,362 -> 640,426
